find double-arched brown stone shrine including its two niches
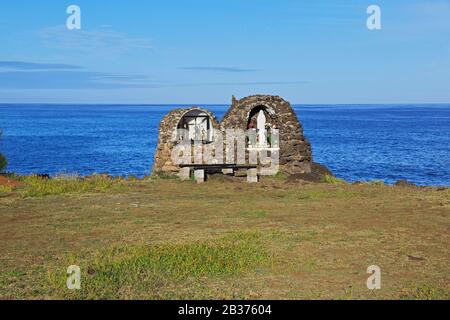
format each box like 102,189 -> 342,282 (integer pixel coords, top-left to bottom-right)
153,95 -> 313,175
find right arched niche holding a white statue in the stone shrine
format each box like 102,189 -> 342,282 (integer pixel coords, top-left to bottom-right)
247,106 -> 278,149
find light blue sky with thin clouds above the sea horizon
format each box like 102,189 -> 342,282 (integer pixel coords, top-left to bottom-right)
0,0 -> 450,104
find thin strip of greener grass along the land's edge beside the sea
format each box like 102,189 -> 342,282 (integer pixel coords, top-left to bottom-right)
0,173 -> 450,198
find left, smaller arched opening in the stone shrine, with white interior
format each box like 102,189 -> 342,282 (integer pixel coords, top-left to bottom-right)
177,110 -> 214,143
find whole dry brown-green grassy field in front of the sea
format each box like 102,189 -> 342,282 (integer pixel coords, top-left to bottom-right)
0,176 -> 450,299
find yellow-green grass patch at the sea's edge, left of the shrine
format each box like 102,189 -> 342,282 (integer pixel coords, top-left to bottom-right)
19,175 -> 121,197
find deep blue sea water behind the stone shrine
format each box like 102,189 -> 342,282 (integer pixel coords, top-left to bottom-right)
0,104 -> 450,186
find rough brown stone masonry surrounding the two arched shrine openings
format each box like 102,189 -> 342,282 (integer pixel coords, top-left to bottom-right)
153,95 -> 313,175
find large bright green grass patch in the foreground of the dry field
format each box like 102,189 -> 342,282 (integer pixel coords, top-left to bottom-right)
49,232 -> 269,299
